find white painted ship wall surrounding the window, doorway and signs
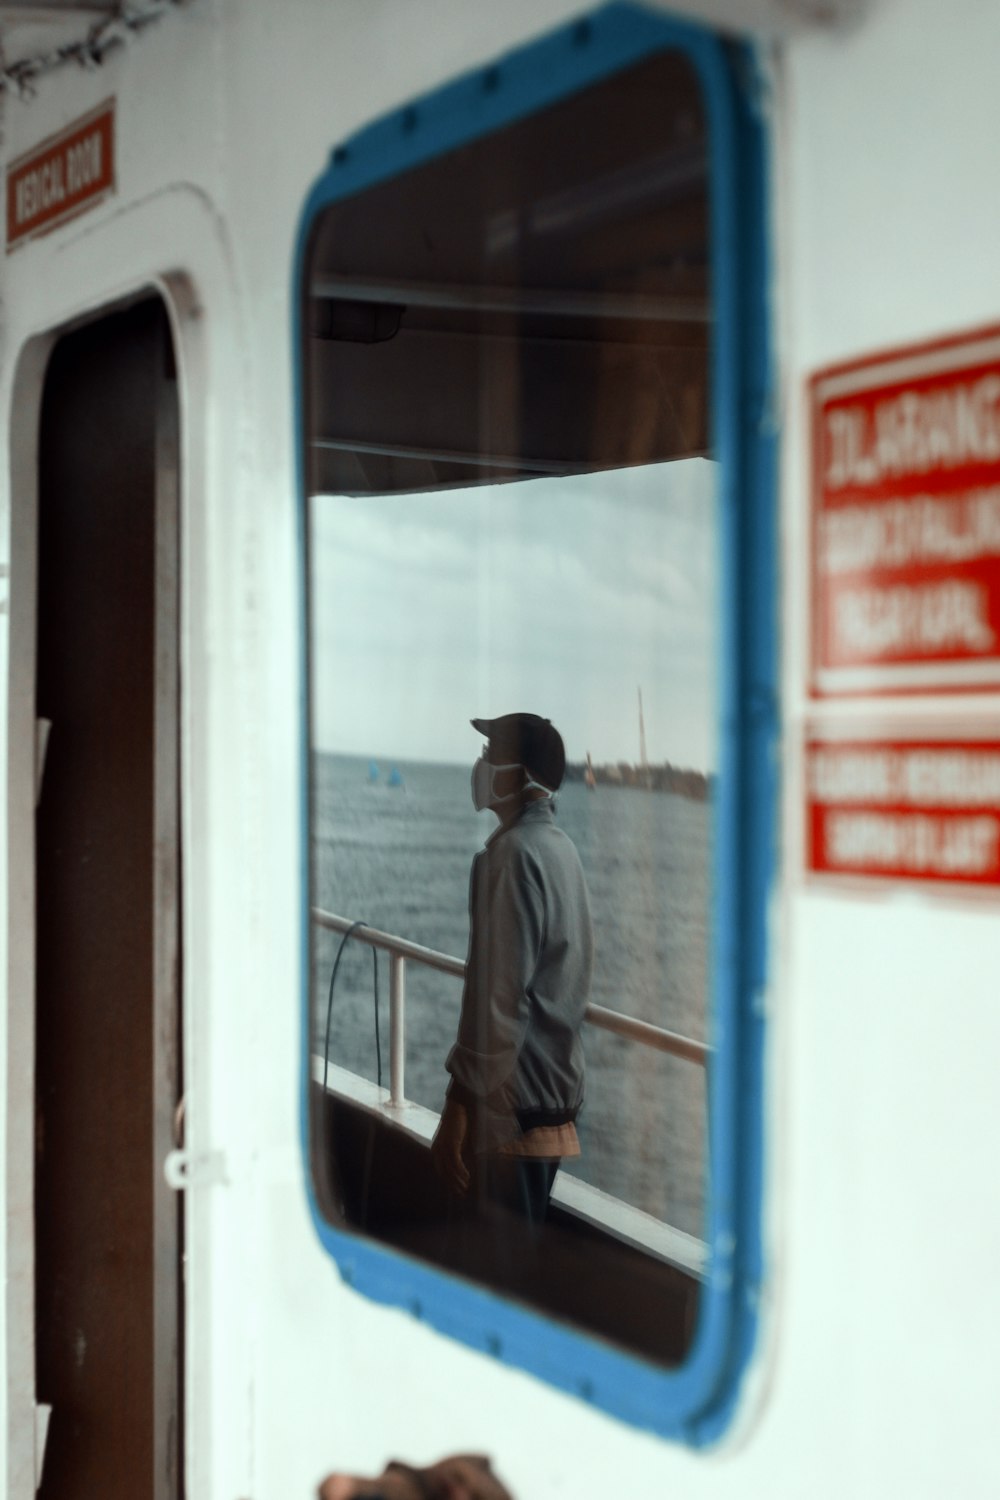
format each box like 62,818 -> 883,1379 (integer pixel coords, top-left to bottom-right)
0,0 -> 1000,1500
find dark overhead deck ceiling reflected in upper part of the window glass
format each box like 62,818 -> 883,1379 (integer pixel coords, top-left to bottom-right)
306,54 -> 711,494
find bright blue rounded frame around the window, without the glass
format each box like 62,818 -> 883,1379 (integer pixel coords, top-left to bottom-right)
294,5 -> 778,1445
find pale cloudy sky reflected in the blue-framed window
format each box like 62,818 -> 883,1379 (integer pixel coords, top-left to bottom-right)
310,459 -> 718,771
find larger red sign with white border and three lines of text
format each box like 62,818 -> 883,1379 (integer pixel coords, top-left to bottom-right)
811,329 -> 1000,695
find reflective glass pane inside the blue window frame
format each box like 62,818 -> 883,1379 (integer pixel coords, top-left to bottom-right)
303,54 -> 718,1364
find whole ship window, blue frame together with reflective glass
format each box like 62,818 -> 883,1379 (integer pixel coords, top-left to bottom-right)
300,8 -> 771,1437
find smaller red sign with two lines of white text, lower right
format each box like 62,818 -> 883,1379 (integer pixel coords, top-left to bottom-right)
805,738 -> 1000,891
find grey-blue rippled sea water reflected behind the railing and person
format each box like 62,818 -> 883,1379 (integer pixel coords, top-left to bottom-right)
312,753 -> 712,1235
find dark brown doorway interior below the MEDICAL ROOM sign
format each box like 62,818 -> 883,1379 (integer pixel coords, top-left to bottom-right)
36,299 -> 180,1500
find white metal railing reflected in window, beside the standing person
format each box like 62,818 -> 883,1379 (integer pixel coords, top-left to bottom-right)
312,906 -> 711,1107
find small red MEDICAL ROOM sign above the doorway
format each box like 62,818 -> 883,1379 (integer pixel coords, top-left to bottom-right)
7,99 -> 114,251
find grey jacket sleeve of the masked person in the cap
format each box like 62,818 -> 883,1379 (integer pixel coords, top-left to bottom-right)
445,846 -> 544,1103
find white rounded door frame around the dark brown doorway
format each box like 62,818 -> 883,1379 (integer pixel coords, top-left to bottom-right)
0,289 -> 183,1500
